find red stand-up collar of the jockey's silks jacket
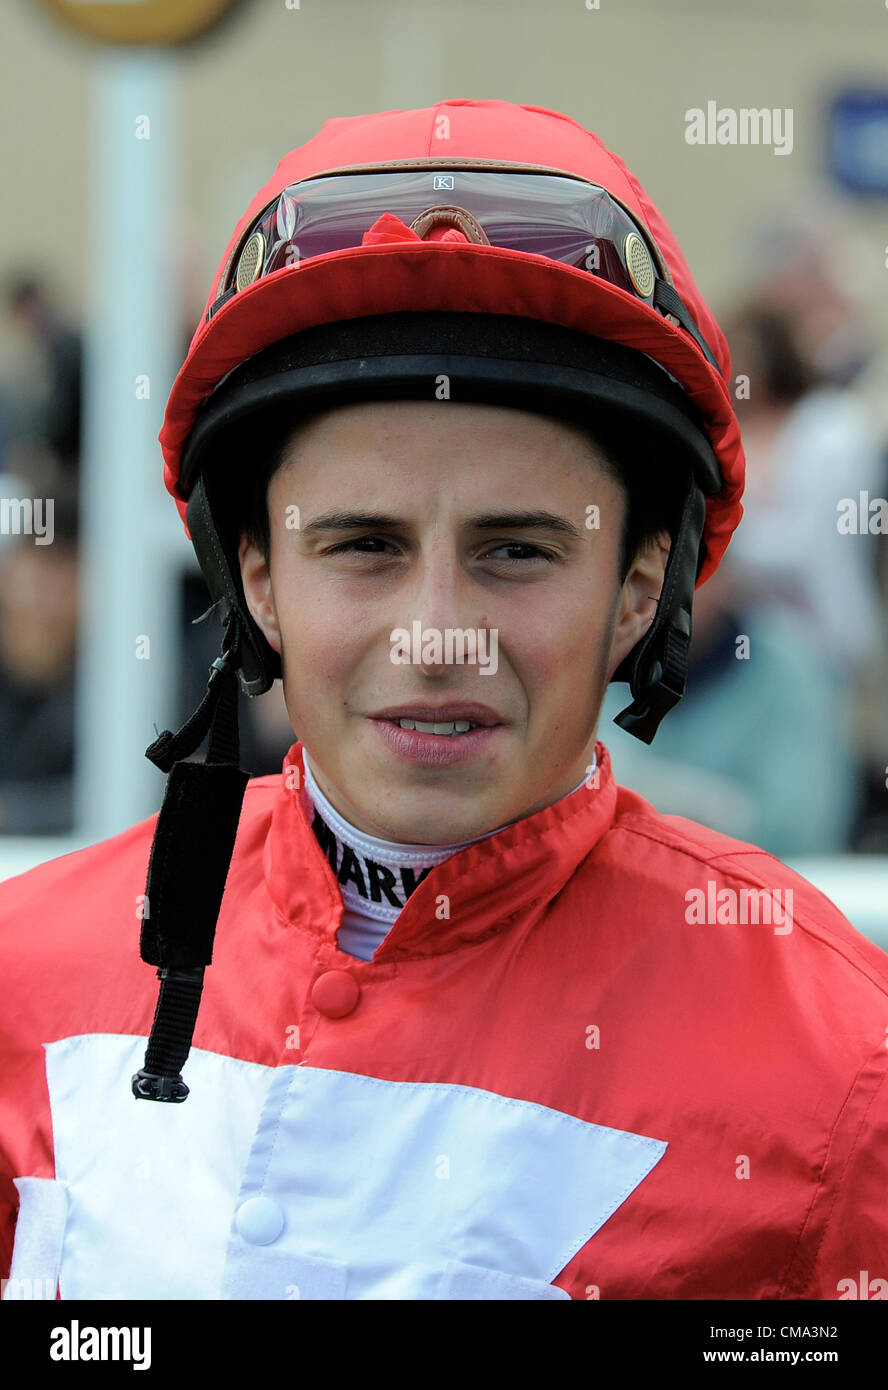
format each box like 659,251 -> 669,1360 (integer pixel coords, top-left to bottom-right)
263,742 -> 617,965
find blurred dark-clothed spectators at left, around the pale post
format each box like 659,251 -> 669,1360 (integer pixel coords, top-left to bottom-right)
0,274 -> 293,835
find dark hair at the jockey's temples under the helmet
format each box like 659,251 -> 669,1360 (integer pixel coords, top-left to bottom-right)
239,416 -> 686,584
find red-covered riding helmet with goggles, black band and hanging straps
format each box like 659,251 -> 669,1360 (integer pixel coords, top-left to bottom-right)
132,100 -> 743,1101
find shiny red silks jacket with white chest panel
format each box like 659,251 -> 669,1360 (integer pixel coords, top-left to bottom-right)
0,742 -> 888,1300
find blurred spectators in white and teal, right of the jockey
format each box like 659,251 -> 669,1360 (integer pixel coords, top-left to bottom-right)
599,207 -> 888,859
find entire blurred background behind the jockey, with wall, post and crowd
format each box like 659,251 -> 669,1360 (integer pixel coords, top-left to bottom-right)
0,0 -> 888,947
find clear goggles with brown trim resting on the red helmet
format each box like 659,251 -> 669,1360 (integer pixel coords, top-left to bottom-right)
207,160 -> 721,373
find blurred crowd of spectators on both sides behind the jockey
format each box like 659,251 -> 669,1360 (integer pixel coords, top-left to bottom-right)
0,198 -> 888,859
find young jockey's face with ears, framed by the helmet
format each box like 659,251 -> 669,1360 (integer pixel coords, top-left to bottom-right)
239,400 -> 668,844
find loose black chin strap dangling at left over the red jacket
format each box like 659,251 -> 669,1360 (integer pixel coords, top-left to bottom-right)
132,609 -> 249,1101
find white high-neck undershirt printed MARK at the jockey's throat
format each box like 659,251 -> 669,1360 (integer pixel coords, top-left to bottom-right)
300,746 -> 598,960
